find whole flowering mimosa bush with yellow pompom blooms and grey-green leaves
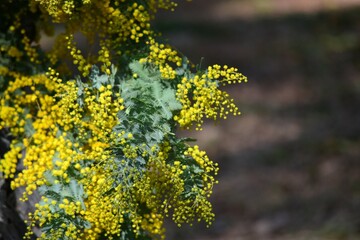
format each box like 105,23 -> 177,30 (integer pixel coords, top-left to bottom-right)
0,0 -> 246,240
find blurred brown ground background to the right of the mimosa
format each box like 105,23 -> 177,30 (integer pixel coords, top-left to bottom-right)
155,0 -> 360,240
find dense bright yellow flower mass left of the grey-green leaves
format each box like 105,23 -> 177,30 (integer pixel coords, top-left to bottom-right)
0,69 -> 131,239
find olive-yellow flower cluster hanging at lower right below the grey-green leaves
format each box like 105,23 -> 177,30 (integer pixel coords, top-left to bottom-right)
134,142 -> 218,236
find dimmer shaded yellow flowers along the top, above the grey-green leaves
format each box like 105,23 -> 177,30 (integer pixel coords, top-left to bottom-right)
25,0 -> 182,79
